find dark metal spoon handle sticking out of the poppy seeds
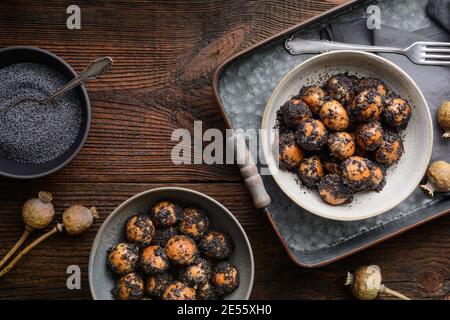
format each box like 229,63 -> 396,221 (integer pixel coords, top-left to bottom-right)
42,57 -> 113,104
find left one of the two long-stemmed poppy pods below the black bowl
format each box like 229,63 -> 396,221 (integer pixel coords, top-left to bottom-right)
0,191 -> 55,267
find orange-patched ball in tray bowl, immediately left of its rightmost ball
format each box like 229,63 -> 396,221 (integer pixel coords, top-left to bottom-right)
351,90 -> 383,121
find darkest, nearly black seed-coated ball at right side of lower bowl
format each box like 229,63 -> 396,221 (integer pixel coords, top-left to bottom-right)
198,231 -> 234,260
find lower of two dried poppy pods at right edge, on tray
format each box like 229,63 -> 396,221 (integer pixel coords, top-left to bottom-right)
420,161 -> 450,197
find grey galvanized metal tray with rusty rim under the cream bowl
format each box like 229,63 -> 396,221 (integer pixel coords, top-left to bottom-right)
213,0 -> 450,267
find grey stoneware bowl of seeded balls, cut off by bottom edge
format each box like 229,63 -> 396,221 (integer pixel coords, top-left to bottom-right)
89,187 -> 254,300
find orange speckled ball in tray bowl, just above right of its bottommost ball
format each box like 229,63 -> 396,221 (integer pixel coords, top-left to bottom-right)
342,156 -> 371,188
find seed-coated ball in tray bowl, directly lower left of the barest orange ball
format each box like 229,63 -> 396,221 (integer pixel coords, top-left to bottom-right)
295,119 -> 328,151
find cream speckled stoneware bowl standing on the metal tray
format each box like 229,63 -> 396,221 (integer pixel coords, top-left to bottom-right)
261,50 -> 433,221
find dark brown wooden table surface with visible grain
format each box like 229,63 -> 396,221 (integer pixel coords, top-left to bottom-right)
0,0 -> 450,299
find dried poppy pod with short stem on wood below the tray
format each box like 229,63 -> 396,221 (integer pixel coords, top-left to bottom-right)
345,265 -> 411,300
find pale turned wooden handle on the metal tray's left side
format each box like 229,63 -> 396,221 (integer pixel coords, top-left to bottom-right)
228,134 -> 271,209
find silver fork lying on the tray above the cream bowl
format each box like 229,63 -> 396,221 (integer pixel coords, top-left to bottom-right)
285,37 -> 450,66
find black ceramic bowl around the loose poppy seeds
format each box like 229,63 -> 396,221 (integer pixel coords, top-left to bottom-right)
0,46 -> 91,179
